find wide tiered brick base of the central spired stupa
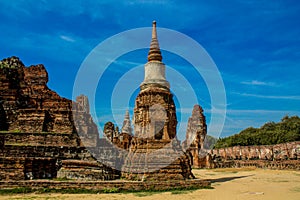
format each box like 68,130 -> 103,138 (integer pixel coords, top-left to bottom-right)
122,138 -> 194,181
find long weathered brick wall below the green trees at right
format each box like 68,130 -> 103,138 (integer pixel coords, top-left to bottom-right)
199,141 -> 300,170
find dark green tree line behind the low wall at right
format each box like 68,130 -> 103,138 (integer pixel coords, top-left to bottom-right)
214,116 -> 300,149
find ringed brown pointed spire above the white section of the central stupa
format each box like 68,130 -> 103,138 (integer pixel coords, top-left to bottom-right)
148,21 -> 162,62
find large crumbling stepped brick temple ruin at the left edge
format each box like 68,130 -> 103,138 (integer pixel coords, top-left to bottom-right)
0,57 -> 120,180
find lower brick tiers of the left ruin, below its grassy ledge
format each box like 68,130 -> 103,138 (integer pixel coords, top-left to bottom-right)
0,132 -> 120,181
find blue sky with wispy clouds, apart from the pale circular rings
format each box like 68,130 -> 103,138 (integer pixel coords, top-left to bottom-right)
0,0 -> 300,139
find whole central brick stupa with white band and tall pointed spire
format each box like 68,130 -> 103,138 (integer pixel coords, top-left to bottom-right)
122,22 -> 193,180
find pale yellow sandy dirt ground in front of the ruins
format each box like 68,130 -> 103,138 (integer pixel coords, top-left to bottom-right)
0,168 -> 300,200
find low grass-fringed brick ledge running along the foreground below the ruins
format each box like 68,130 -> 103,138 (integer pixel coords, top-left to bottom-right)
0,179 -> 211,192
